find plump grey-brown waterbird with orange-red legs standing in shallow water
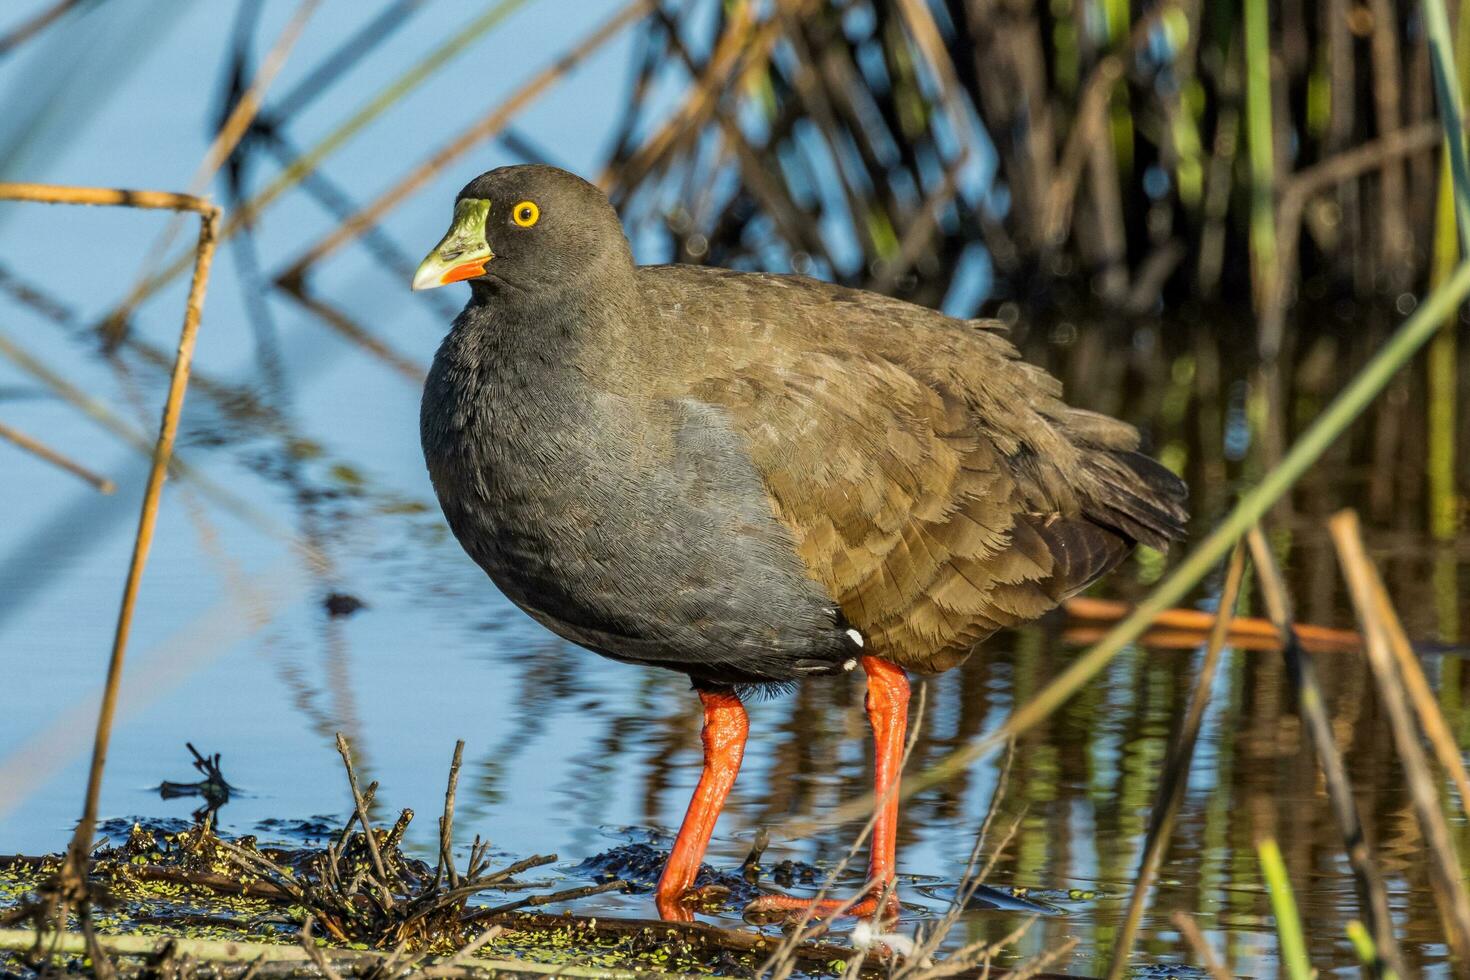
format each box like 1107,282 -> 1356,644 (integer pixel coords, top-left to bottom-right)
413,165 -> 1188,921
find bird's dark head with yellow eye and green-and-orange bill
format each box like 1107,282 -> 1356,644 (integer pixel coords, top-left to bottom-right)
413,165 -> 632,292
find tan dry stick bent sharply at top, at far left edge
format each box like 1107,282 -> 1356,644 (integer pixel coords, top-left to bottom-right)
0,184 -> 219,901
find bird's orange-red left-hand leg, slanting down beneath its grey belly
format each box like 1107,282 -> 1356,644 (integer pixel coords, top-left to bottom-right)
654,691 -> 750,923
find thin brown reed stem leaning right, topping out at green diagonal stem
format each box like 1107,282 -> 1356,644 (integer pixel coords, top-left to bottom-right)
1107,541 -> 1245,980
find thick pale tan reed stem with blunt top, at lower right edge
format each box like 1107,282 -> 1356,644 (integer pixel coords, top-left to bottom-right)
1327,510 -> 1470,968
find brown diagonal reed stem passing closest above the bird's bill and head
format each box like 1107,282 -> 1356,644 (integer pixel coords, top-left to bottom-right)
276,0 -> 654,287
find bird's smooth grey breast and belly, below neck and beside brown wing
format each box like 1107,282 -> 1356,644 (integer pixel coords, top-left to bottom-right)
422,326 -> 850,679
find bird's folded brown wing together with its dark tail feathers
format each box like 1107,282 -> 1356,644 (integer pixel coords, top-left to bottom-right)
673,271 -> 1185,671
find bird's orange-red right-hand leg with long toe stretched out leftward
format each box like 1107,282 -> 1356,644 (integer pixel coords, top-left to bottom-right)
745,657 -> 908,918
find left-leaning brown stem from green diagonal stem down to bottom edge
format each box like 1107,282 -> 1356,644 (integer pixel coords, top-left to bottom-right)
1247,525 -> 1411,977
